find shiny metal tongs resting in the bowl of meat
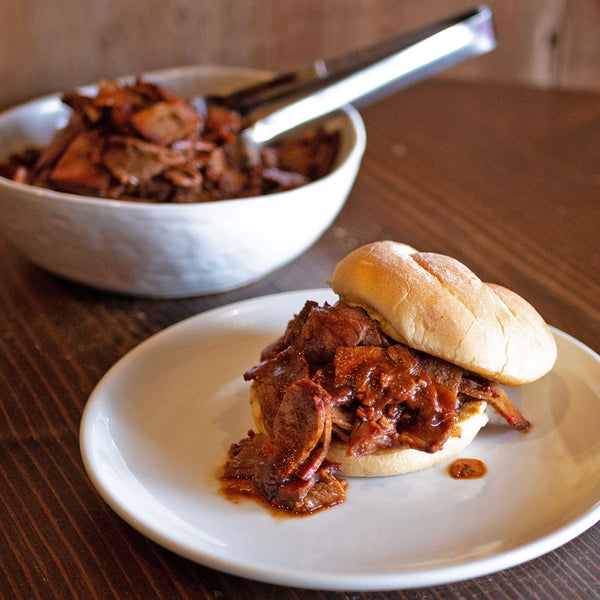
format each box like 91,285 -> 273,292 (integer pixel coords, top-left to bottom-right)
195,6 -> 496,164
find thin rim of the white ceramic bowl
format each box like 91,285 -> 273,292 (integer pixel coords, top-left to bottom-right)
0,65 -> 366,212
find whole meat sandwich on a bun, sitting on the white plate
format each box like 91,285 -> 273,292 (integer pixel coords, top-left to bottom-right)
223,242 -> 556,513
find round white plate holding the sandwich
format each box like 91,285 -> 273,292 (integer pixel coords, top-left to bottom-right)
81,290 -> 600,590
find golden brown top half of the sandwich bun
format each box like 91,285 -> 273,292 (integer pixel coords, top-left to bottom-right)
330,242 -> 556,385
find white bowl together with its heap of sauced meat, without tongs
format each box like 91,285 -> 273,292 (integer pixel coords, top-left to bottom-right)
0,66 -> 366,298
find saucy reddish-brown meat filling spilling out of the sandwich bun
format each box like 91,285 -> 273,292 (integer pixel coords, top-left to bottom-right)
223,301 -> 529,513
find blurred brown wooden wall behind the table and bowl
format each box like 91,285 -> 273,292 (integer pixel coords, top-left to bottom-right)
0,0 -> 600,108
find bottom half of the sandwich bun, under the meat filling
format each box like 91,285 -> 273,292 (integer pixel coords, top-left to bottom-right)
250,383 -> 488,477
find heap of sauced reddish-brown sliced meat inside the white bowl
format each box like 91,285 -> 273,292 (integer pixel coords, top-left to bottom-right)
0,80 -> 339,203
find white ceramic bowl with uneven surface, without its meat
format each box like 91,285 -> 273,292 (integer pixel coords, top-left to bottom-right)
0,66 -> 366,298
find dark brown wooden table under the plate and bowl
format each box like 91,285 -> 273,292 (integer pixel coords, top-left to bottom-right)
0,81 -> 600,600
